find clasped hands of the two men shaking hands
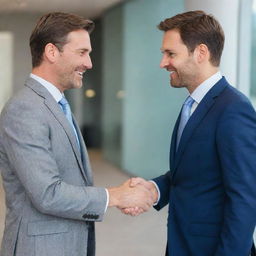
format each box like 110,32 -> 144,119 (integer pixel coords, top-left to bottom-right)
108,178 -> 158,216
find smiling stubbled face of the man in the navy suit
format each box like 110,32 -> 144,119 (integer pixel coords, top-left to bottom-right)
160,30 -> 199,91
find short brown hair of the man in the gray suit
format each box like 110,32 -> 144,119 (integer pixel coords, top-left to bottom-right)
30,12 -> 94,67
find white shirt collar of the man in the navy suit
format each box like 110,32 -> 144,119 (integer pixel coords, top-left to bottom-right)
190,71 -> 222,104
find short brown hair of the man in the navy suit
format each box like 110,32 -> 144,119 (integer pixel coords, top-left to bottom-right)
158,11 -> 225,66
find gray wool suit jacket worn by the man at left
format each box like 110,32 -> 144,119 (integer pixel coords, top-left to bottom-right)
0,78 -> 107,256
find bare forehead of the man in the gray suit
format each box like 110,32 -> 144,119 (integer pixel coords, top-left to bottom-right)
67,29 -> 91,50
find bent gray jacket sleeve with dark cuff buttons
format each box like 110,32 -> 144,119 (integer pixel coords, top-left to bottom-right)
0,99 -> 107,221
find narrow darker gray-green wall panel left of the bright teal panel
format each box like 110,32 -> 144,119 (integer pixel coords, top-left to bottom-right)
101,5 -> 124,166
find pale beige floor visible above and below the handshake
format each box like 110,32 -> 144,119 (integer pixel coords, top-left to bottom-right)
0,151 -> 167,256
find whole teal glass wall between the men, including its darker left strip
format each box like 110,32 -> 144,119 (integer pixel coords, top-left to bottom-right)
103,0 -> 186,178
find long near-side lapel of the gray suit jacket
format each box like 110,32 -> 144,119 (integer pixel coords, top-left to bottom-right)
25,78 -> 89,183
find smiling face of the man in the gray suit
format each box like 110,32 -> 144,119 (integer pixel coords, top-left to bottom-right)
55,30 -> 92,91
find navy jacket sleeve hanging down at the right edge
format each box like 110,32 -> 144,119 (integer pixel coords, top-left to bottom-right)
214,101 -> 256,256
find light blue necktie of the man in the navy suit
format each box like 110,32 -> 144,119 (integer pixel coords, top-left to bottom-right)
176,96 -> 195,149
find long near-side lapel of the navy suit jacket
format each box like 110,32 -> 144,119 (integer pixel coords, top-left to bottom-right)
171,77 -> 228,170
